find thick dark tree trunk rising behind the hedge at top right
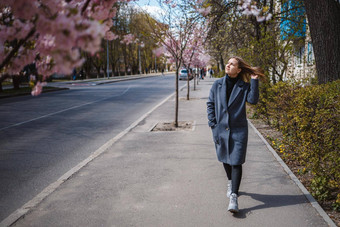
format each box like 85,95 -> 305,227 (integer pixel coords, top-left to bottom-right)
304,0 -> 340,84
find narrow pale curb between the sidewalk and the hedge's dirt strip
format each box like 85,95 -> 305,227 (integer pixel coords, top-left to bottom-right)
248,119 -> 336,227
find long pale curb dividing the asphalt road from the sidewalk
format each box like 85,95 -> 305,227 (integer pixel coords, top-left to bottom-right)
0,84 -> 187,227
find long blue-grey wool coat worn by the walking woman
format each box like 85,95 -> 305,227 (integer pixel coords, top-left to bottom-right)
207,77 -> 259,165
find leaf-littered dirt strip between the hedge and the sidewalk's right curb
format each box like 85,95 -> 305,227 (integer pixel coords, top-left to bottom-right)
247,106 -> 340,227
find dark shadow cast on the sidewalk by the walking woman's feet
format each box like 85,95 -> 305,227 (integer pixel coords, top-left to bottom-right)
233,192 -> 308,218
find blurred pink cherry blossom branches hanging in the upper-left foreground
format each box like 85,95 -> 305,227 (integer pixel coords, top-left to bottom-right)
0,0 -> 135,95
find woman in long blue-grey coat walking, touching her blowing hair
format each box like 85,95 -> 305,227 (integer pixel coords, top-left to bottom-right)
207,57 -> 264,212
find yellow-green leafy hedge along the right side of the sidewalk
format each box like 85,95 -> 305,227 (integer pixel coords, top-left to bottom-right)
255,80 -> 340,211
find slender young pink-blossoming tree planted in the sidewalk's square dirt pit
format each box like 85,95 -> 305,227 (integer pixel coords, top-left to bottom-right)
145,0 -> 209,127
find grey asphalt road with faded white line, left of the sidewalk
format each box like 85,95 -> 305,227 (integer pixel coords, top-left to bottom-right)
0,75 -> 185,220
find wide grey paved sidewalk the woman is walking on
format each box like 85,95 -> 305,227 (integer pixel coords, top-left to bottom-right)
6,79 -> 334,227
